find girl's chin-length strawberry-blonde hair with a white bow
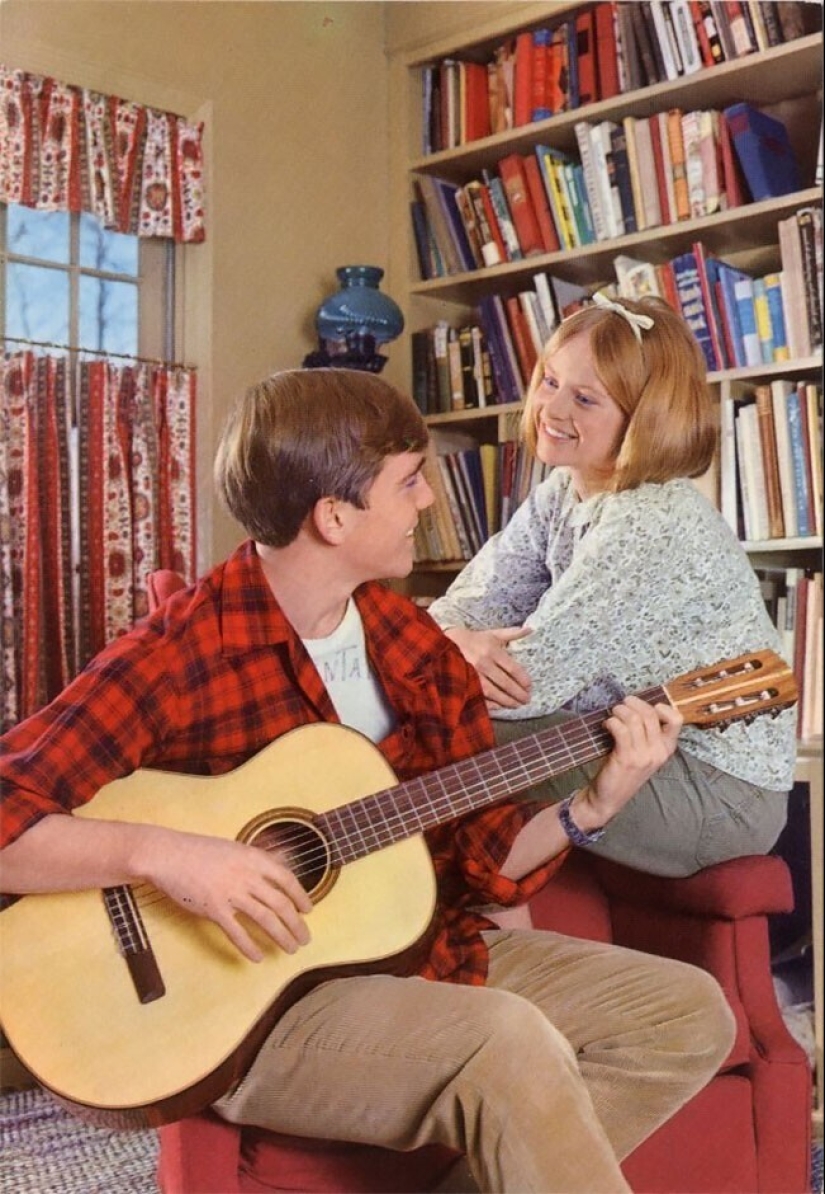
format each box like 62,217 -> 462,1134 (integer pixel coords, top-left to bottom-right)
522,297 -> 718,493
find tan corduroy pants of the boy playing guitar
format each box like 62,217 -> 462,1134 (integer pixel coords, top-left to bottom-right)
216,930 -> 734,1194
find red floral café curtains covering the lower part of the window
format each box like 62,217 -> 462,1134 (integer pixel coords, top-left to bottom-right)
0,352 -> 196,730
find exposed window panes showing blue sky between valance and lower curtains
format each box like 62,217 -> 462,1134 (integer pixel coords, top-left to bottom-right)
0,203 -> 176,361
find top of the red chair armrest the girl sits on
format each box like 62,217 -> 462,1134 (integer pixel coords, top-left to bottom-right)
590,855 -> 794,921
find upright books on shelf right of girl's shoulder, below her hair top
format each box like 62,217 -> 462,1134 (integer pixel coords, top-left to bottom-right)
720,377 -> 823,542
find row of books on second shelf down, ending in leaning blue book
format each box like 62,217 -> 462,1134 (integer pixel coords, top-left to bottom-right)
411,103 -> 801,279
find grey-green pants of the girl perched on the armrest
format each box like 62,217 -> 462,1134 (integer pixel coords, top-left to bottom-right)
493,713 -> 788,878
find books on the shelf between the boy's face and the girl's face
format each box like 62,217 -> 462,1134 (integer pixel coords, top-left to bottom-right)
414,439 -> 548,564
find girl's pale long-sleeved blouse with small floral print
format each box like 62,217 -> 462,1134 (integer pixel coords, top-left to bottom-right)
430,468 -> 796,792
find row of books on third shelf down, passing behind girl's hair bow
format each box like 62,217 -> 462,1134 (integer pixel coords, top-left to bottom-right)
412,208 -> 823,414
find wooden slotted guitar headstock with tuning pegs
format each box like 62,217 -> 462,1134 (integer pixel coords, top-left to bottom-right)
664,651 -> 798,727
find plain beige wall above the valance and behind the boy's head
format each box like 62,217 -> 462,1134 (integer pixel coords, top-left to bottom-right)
0,0 -> 389,566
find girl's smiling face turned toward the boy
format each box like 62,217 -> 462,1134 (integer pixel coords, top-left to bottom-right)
532,332 -> 627,500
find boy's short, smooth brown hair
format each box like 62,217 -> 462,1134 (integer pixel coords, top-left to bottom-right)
215,369 -> 427,547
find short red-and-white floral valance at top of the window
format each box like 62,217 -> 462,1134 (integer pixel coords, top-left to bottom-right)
0,64 -> 205,242
